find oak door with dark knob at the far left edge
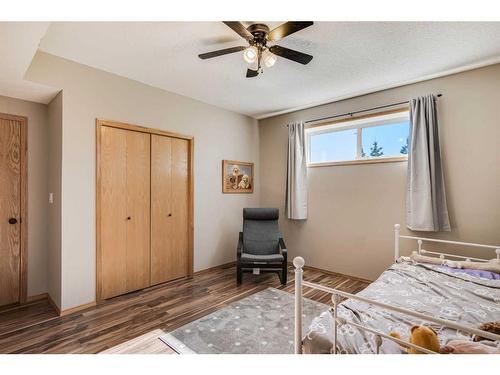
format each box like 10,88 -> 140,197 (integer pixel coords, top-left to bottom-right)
0,118 -> 21,305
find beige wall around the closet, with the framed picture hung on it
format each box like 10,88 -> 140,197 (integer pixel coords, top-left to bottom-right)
27,52 -> 259,309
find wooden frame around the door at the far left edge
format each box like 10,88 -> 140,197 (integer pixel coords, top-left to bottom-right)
0,113 -> 28,303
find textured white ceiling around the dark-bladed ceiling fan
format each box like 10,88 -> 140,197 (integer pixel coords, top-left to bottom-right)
40,22 -> 500,118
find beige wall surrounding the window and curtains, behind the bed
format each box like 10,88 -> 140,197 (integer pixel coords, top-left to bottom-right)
259,65 -> 500,279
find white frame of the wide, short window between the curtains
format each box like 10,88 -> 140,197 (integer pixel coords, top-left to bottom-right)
305,108 -> 410,167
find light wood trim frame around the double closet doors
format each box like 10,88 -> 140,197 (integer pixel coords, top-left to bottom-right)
96,118 -> 194,301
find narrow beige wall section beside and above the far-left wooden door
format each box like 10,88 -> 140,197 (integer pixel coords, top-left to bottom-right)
0,96 -> 48,296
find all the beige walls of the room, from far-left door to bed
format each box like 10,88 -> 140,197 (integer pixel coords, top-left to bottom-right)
13,52 -> 500,309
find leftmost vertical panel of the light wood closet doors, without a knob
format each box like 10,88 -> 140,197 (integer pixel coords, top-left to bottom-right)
99,127 -> 127,298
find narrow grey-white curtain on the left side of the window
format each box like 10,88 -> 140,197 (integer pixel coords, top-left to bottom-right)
286,122 -> 307,220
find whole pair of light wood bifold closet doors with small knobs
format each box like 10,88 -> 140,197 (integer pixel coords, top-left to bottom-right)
97,120 -> 192,299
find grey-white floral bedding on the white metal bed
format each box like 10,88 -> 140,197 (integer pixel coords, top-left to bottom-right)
303,262 -> 500,354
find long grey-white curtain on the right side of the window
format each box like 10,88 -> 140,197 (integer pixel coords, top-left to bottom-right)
406,95 -> 451,232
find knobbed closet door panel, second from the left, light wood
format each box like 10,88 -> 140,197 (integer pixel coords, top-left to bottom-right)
126,131 -> 151,291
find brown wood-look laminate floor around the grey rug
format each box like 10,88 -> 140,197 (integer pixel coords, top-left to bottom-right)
0,265 -> 369,353
